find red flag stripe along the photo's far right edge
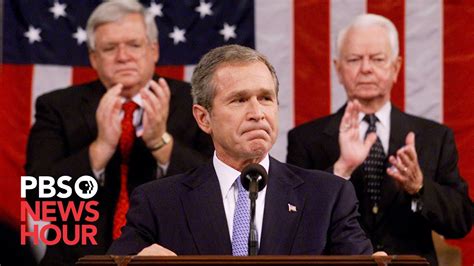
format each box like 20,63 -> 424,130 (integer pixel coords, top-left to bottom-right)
443,0 -> 474,265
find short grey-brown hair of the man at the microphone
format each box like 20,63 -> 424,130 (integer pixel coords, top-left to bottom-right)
191,44 -> 279,111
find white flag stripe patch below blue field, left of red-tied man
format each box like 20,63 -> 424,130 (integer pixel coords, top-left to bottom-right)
31,65 -> 72,123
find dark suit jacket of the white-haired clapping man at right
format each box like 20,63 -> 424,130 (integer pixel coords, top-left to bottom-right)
287,106 -> 471,263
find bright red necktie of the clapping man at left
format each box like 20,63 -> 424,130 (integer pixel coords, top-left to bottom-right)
112,101 -> 138,240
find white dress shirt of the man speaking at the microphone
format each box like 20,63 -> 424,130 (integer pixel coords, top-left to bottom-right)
212,152 -> 270,244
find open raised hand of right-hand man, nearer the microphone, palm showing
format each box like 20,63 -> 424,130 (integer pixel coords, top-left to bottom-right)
334,100 -> 377,177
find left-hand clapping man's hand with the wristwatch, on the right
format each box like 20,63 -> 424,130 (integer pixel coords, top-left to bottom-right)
140,78 -> 173,164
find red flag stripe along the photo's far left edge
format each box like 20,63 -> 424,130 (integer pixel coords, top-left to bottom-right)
0,65 -> 33,226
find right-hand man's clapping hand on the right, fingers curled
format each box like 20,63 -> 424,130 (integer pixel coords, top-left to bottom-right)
387,132 -> 423,195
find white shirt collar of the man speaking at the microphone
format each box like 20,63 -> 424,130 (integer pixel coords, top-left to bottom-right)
212,151 -> 270,198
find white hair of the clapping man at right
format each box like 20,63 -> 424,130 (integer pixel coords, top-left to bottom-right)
336,14 -> 399,60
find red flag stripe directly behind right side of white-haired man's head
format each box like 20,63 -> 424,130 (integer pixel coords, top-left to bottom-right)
367,0 -> 405,110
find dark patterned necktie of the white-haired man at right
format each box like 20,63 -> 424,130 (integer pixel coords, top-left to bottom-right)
364,114 -> 386,214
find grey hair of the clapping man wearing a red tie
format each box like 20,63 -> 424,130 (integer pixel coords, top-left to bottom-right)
86,0 -> 158,51
